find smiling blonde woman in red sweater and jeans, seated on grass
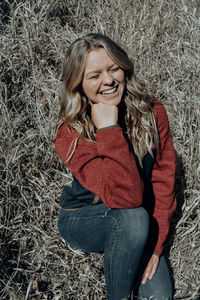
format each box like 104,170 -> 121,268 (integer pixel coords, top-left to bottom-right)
55,34 -> 176,300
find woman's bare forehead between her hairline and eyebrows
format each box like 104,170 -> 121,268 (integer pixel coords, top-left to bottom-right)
85,48 -> 114,72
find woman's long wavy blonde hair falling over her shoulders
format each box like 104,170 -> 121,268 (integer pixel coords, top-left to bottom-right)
59,34 -> 159,163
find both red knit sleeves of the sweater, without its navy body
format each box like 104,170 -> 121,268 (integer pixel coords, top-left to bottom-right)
55,100 -> 176,254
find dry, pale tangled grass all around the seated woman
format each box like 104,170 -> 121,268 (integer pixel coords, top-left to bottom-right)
0,0 -> 200,300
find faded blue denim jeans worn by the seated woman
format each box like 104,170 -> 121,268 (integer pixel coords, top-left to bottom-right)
58,203 -> 173,300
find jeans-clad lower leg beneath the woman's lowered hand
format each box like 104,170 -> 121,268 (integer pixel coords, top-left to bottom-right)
136,251 -> 173,300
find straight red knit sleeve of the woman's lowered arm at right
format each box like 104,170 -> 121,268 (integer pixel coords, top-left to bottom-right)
152,101 -> 176,254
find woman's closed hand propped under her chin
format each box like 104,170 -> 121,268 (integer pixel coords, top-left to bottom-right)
90,102 -> 118,129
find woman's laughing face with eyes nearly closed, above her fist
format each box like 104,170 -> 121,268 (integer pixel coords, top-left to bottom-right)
82,48 -> 125,105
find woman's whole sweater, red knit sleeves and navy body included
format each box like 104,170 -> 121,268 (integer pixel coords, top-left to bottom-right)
55,99 -> 176,254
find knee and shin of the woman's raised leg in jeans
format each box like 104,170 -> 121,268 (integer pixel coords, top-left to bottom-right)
104,207 -> 149,300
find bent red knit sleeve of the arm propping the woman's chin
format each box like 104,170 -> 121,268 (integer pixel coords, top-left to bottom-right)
55,124 -> 143,208
